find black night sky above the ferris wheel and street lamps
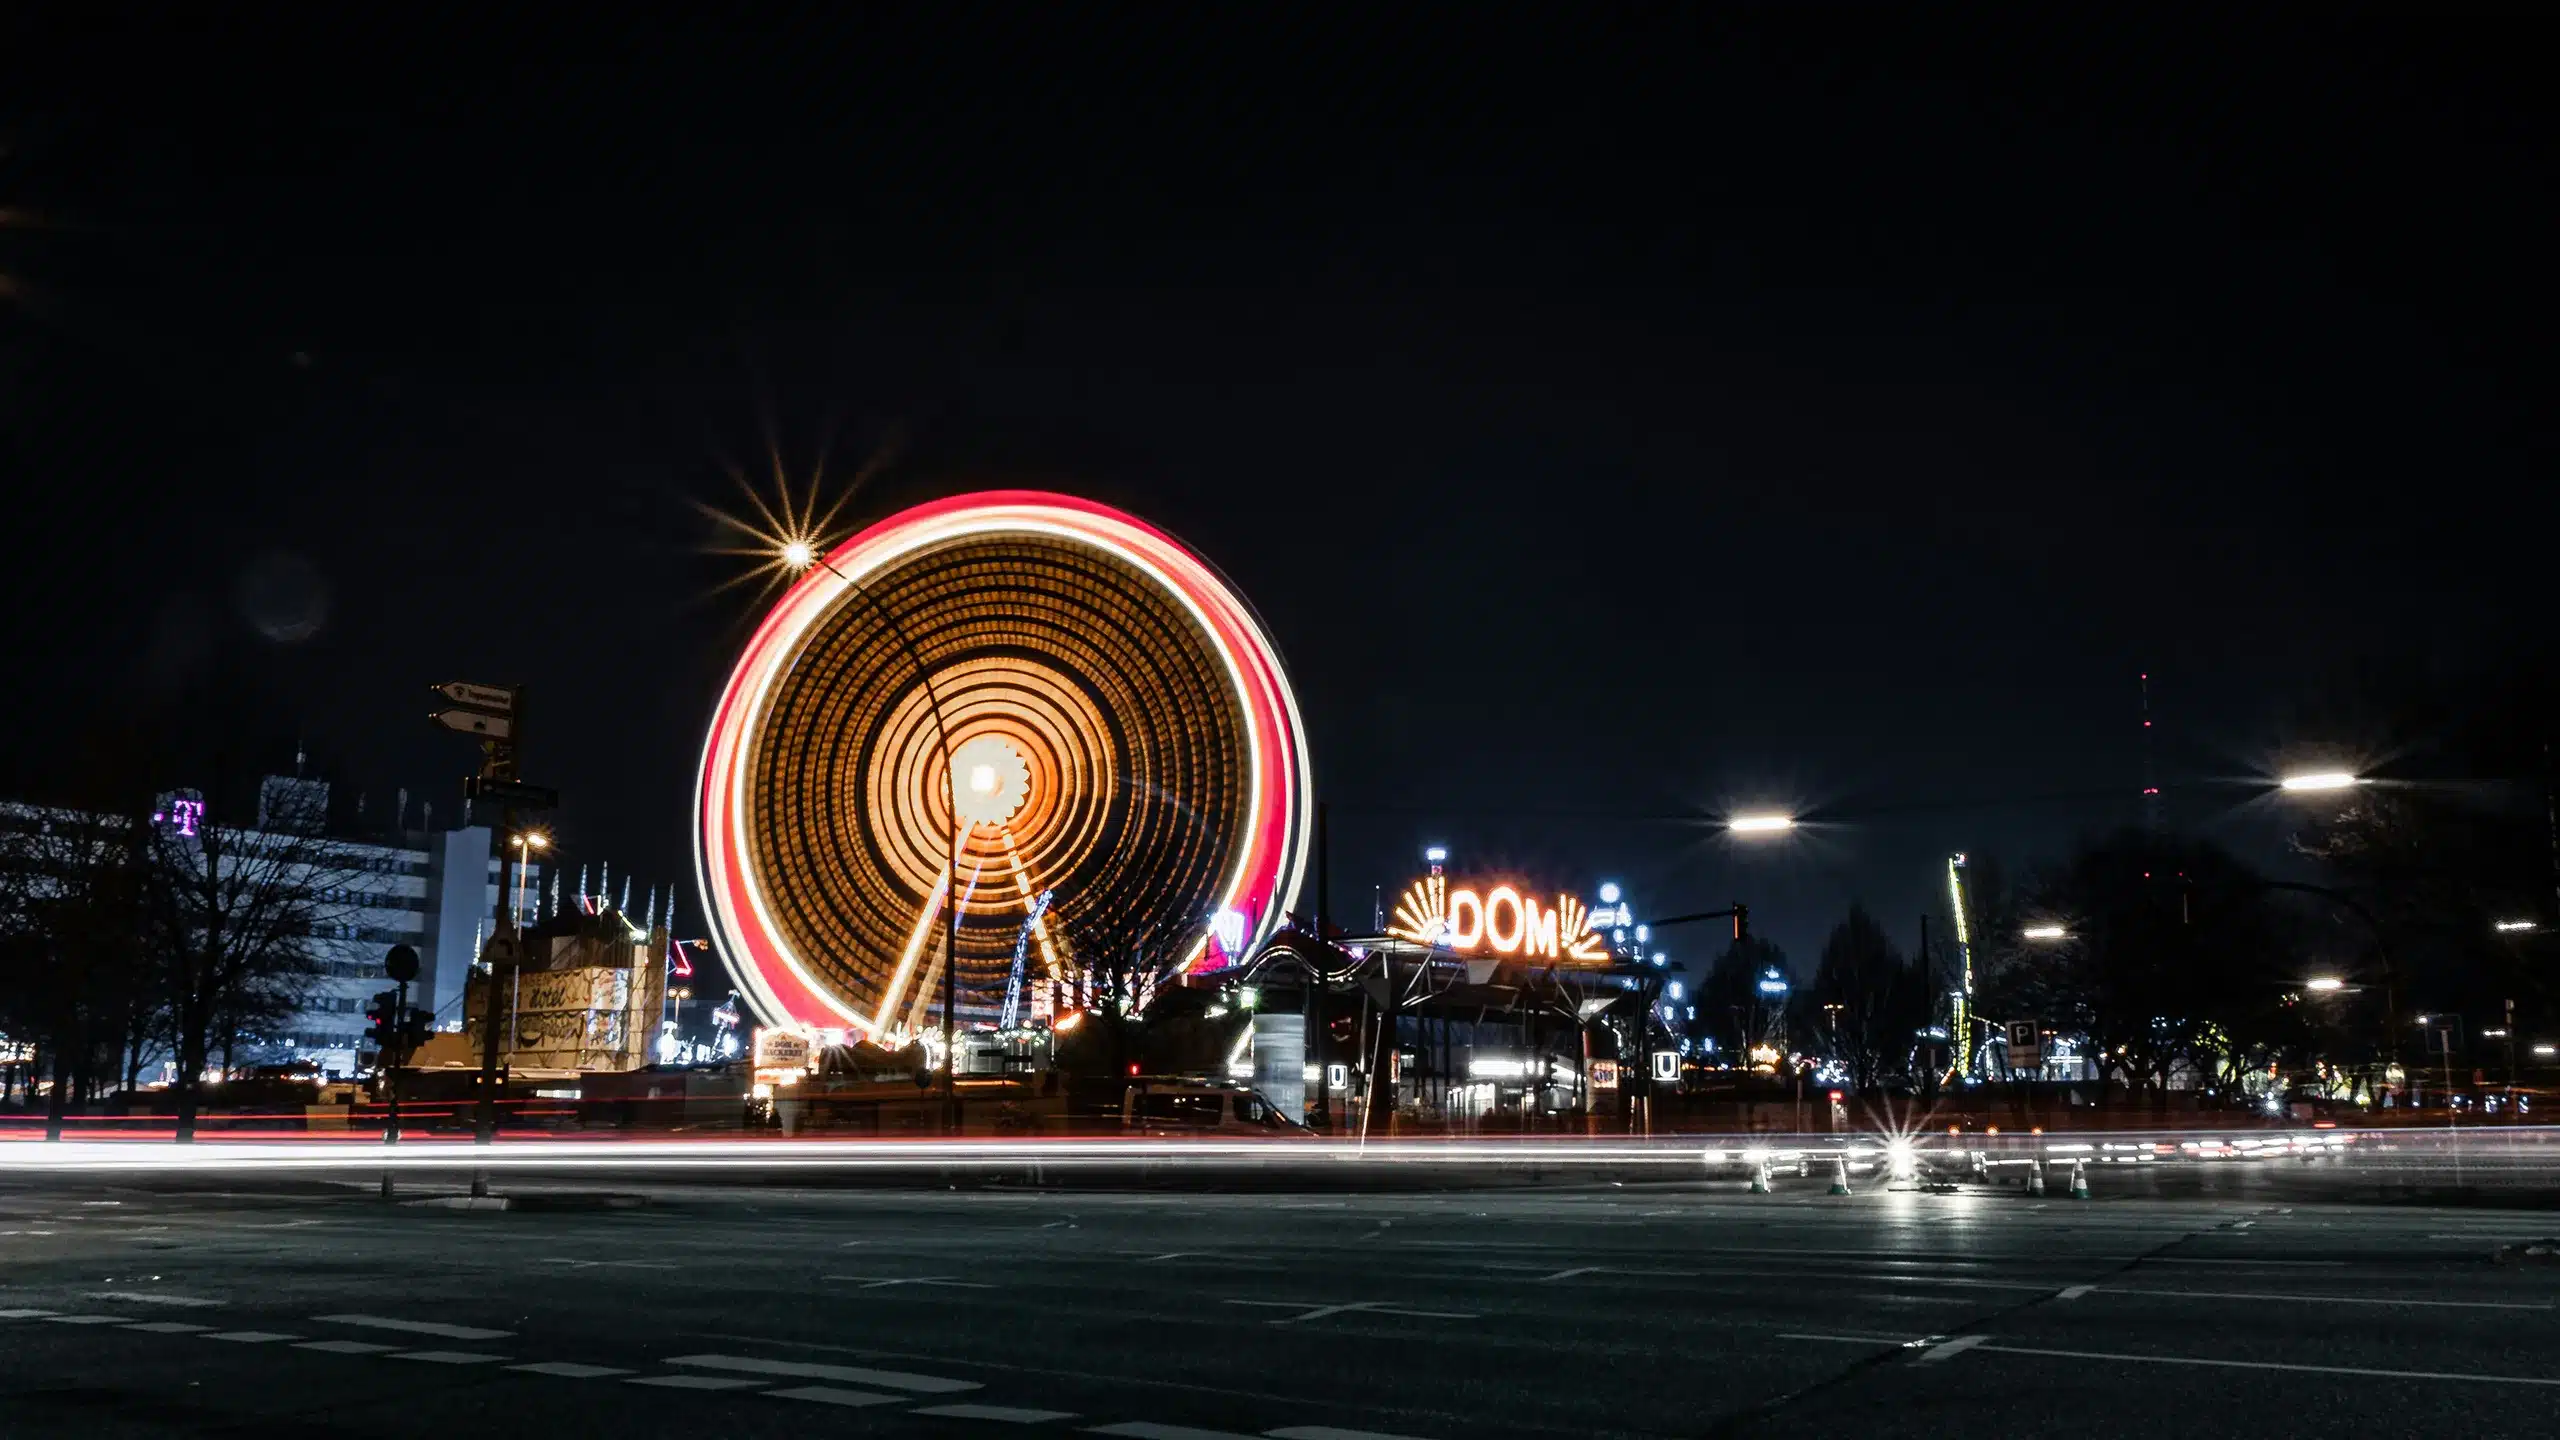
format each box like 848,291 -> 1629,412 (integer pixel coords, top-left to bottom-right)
0,5 -> 2560,963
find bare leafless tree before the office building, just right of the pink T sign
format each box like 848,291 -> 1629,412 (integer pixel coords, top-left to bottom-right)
151,779 -> 358,1143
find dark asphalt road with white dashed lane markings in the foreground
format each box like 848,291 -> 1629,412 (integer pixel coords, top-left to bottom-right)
0,1171 -> 2560,1440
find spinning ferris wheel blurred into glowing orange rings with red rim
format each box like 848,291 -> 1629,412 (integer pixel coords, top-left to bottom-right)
694,489 -> 1313,1040
